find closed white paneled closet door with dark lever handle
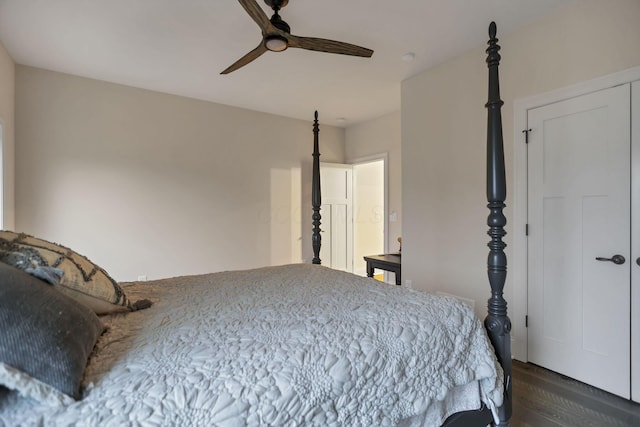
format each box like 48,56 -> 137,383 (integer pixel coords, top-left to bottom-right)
528,84 -> 634,398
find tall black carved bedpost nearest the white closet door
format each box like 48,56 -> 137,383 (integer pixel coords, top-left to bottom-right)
485,22 -> 511,426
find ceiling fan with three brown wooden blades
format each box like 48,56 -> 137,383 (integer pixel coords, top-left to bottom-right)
220,0 -> 373,74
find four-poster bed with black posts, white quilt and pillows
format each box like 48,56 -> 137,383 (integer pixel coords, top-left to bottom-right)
0,23 -> 511,426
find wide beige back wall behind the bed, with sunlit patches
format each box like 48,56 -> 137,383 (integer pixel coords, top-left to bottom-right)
16,66 -> 344,280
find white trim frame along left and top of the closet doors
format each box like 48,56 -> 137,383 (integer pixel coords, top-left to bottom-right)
507,67 -> 640,362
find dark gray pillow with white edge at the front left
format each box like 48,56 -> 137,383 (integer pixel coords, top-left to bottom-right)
0,263 -> 103,404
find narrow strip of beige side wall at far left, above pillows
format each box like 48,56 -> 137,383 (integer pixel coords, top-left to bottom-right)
0,43 -> 16,228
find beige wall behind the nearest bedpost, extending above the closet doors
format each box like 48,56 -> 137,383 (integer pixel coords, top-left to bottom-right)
402,0 -> 640,315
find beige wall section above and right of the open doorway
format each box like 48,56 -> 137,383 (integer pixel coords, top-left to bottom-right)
345,112 -> 402,251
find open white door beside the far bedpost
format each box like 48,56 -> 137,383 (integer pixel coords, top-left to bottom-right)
320,163 -> 353,272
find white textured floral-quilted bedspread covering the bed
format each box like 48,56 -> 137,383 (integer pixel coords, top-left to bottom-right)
0,264 -> 502,427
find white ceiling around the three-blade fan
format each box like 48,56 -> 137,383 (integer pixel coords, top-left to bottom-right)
0,0 -> 574,126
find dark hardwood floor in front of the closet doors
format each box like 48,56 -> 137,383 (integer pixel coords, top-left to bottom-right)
510,360 -> 640,427
